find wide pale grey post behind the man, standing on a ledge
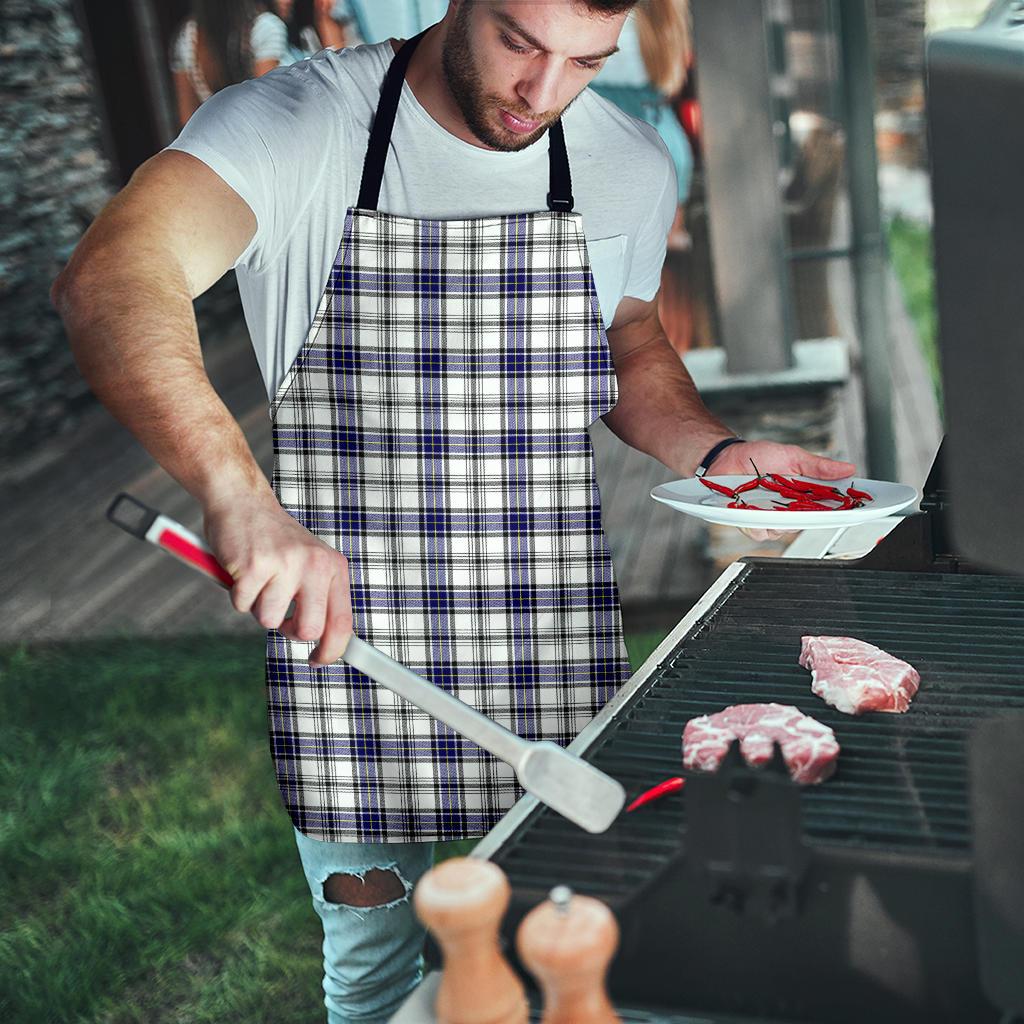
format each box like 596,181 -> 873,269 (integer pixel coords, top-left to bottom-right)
693,0 -> 794,373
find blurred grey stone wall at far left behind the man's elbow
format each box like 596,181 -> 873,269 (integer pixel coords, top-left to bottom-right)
0,0 -> 113,461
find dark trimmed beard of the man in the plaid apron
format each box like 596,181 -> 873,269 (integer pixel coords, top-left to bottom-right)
441,3 -> 564,152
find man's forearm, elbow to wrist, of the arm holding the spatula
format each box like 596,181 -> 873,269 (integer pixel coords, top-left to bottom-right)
52,253 -> 269,508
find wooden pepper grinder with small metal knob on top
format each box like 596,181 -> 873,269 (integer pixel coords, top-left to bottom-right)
516,886 -> 620,1024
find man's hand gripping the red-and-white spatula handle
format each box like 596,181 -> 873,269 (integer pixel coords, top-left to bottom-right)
203,495 -> 352,666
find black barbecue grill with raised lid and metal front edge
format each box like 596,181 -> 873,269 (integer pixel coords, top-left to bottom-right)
393,9 -> 1024,1024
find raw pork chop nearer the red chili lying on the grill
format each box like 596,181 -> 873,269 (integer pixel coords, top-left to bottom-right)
683,703 -> 839,784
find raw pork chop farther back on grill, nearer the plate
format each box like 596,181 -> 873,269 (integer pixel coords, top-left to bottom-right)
800,637 -> 921,715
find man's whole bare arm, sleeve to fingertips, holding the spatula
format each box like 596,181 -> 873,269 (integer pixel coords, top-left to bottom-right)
52,151 -> 351,664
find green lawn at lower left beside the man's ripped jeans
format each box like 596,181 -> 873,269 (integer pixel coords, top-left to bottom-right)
0,636 -> 660,1024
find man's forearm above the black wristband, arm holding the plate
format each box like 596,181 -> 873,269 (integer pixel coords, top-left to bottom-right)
604,331 -> 733,476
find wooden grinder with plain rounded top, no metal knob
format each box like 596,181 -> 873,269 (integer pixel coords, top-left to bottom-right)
413,857 -> 529,1024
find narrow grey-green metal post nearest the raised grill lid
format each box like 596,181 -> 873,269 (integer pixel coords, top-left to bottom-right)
835,0 -> 899,480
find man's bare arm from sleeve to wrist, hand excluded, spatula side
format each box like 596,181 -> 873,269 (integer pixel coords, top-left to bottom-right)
52,152 -> 265,505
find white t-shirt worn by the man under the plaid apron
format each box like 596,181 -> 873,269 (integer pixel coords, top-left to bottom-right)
169,41 -> 676,398
